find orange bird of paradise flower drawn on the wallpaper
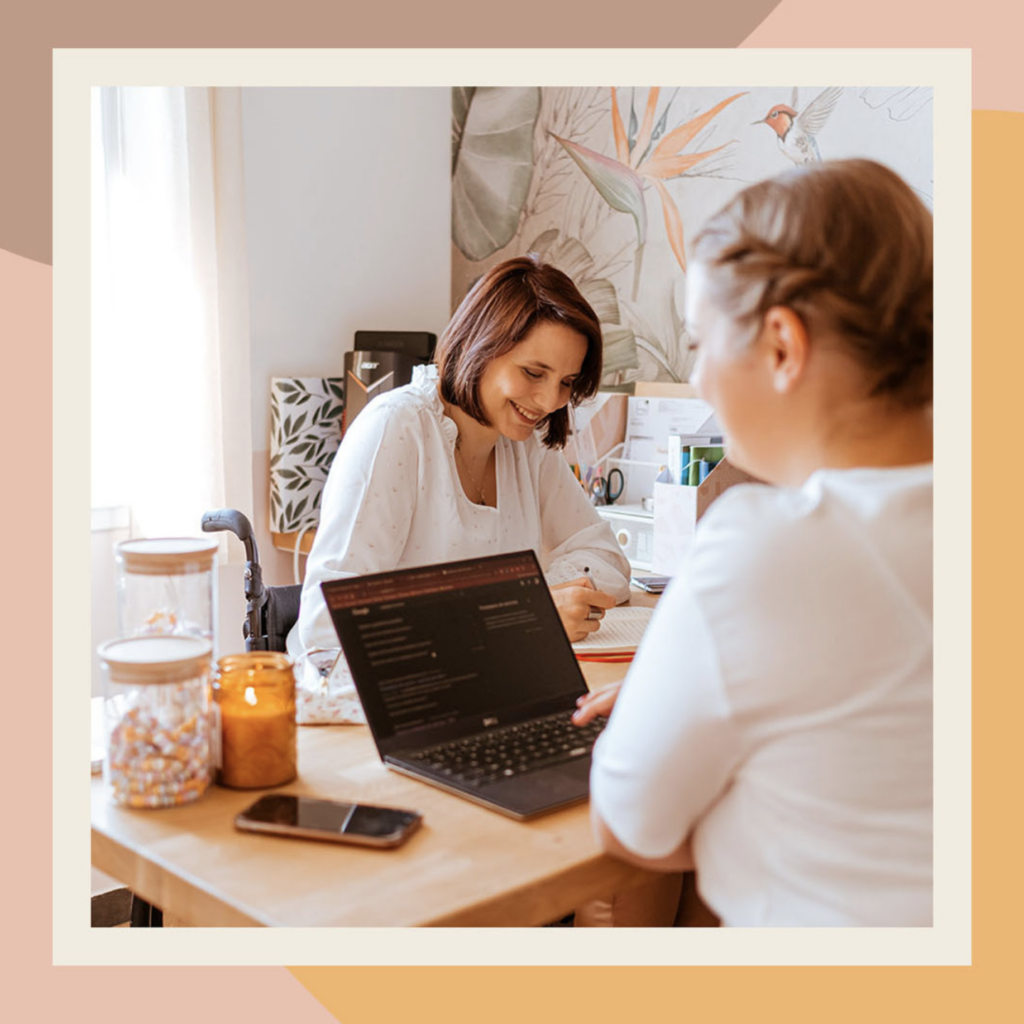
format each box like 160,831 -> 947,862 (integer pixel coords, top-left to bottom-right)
551,87 -> 746,299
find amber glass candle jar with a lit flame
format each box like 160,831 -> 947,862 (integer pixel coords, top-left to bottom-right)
213,650 -> 297,790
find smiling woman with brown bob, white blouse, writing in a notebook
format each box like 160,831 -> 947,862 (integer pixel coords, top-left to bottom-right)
288,256 -> 630,699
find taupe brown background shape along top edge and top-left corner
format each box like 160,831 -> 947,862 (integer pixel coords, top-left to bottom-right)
0,0 -> 777,263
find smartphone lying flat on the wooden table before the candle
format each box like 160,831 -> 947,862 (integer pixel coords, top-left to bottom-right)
234,793 -> 423,847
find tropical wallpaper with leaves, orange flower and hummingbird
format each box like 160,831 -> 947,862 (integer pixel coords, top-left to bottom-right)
452,85 -> 933,390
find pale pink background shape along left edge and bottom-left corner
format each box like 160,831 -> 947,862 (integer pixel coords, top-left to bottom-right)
0,241 -> 334,1024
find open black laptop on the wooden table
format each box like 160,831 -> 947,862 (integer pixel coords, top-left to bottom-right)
321,551 -> 605,819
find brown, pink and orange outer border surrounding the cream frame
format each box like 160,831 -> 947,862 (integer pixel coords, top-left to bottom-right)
0,0 -> 1024,1024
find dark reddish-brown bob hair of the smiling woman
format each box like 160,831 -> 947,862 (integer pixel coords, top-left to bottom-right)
434,253 -> 602,447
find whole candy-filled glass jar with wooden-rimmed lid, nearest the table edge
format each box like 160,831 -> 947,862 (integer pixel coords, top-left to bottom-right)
98,636 -> 213,807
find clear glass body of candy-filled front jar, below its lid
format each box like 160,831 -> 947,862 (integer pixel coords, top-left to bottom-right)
103,670 -> 213,807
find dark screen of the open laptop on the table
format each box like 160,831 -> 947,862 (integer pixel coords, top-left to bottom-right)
322,551 -> 587,749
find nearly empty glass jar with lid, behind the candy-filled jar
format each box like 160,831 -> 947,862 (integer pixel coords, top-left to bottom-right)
117,537 -> 217,649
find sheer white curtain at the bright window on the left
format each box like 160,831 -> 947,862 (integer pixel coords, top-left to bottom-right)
91,87 -> 253,558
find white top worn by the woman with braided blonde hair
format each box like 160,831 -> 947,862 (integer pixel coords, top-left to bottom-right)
591,465 -> 932,927
